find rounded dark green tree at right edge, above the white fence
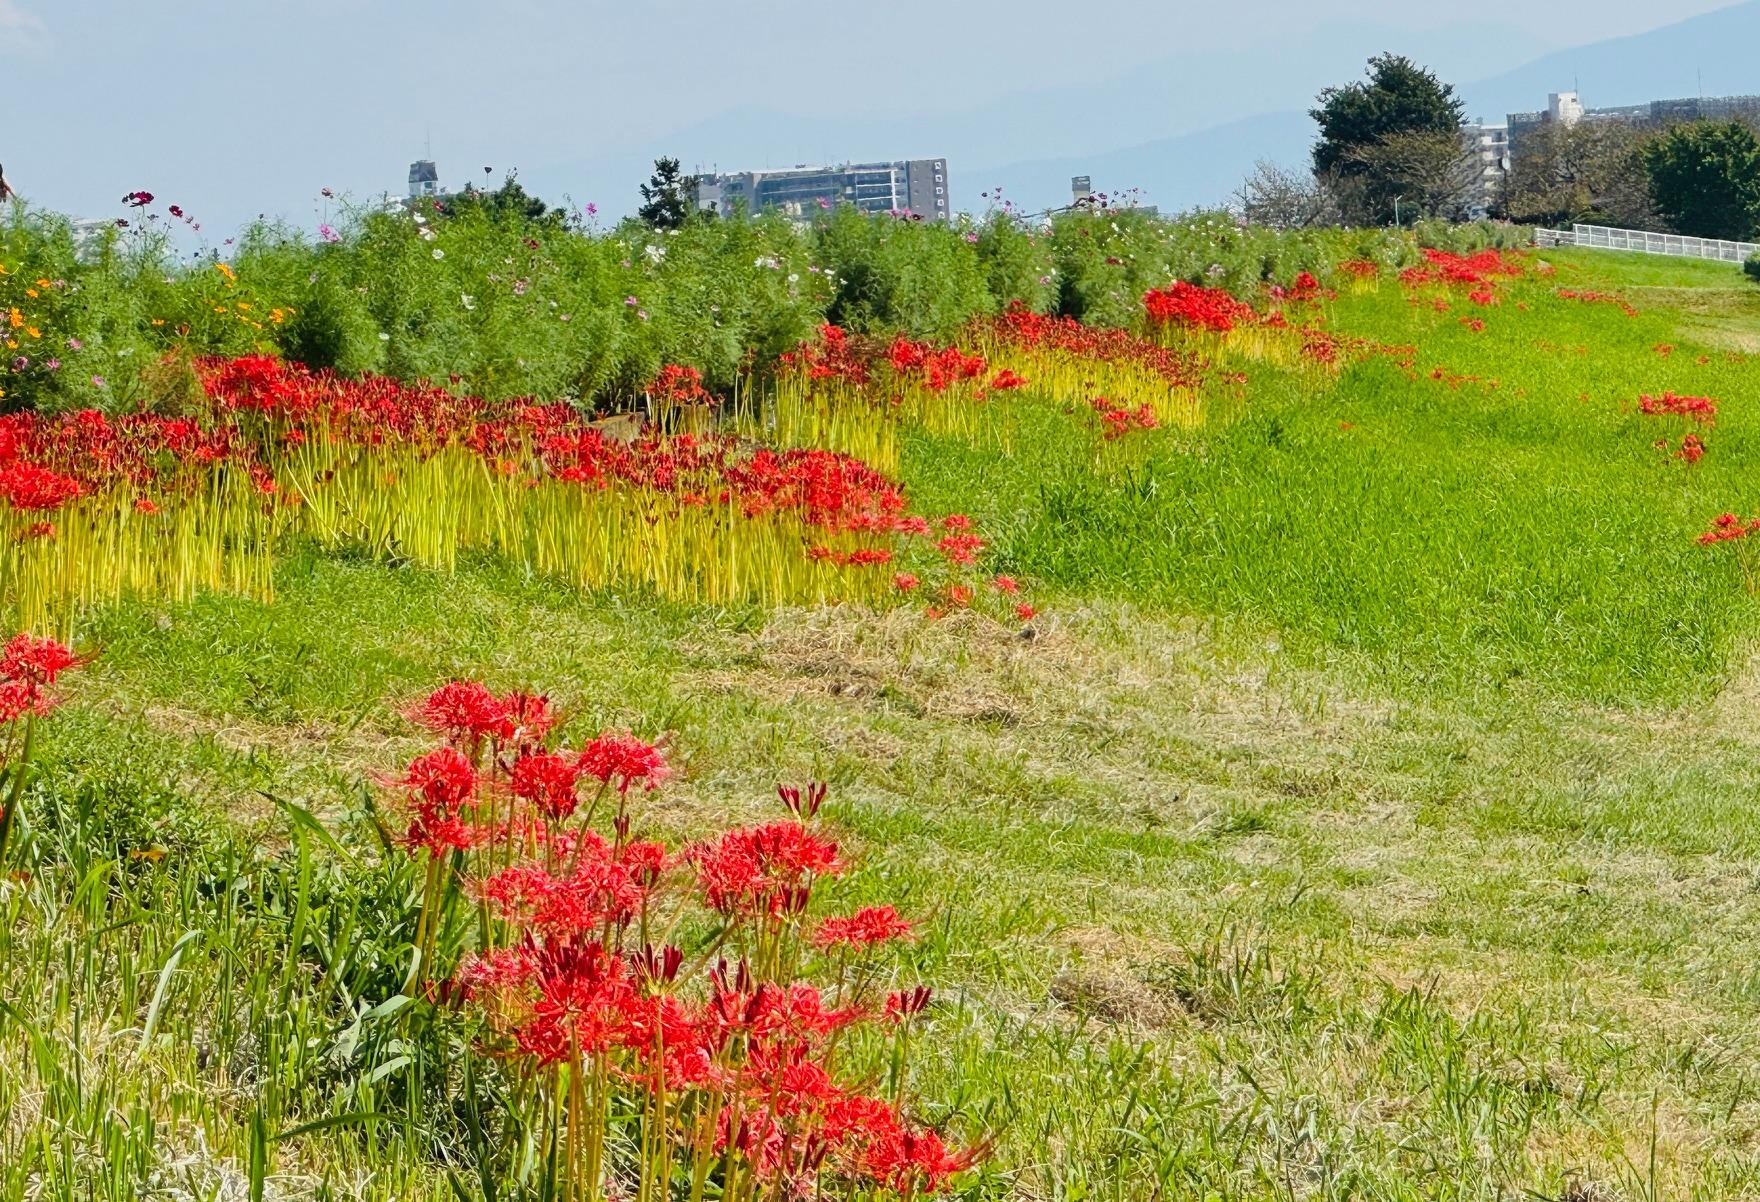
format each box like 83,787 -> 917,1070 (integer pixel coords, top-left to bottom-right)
1644,121 -> 1760,241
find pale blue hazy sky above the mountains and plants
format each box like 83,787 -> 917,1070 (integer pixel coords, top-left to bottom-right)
0,0 -> 1723,230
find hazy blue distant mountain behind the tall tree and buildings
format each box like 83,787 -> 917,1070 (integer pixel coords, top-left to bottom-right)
985,0 -> 1760,209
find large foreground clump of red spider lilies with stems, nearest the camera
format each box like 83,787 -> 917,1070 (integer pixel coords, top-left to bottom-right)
381,681 -> 979,1202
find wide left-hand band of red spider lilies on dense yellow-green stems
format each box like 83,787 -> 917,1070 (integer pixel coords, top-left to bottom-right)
0,357 -> 1017,621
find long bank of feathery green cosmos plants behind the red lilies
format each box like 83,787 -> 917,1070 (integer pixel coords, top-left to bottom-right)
0,194 -> 1510,410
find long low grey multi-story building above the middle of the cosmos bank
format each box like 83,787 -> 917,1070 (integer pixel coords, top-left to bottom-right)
692,158 -> 952,222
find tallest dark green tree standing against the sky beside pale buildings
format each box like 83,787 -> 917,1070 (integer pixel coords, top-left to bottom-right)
1309,55 -> 1466,224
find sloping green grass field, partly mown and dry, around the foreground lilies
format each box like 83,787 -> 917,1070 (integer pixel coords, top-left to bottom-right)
0,252 -> 1760,1202
